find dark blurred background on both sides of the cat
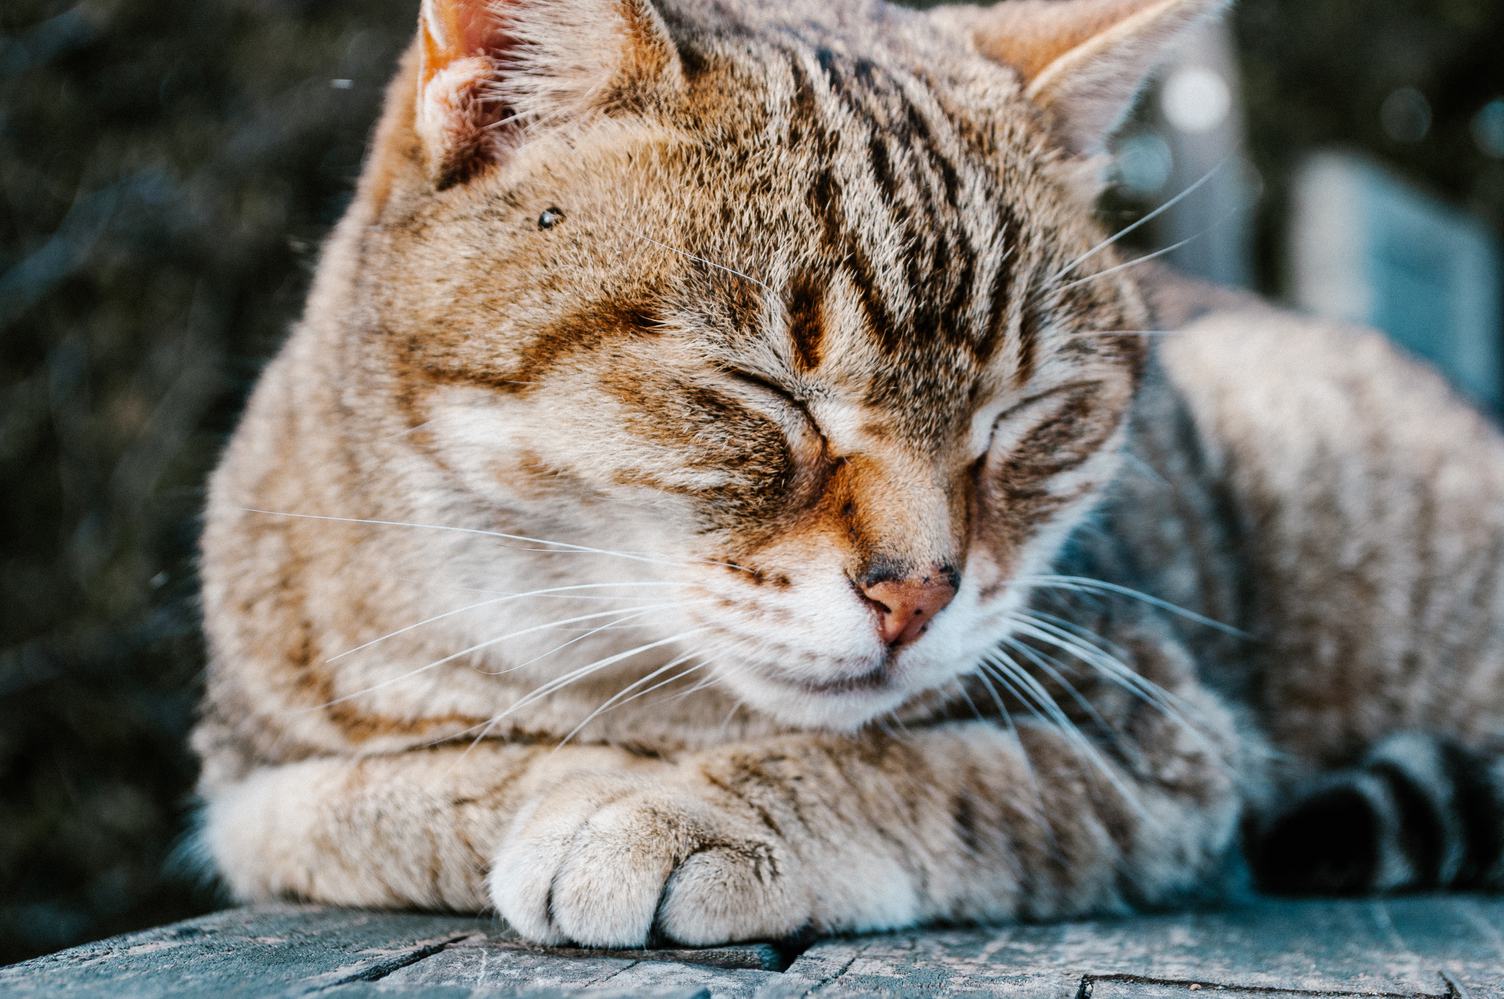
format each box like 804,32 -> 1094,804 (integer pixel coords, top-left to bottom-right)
0,0 -> 1504,963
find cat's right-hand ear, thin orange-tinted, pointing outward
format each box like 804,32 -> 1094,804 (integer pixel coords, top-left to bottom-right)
940,0 -> 1226,155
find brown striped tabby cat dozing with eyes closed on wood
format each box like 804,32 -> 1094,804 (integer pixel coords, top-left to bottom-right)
194,0 -> 1504,946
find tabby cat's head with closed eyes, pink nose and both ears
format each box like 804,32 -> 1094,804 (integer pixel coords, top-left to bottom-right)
352,0 -> 1214,728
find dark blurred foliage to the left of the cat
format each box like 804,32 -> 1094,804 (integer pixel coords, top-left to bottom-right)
0,0 -> 415,963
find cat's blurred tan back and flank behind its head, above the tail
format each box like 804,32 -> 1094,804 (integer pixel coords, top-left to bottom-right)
1120,274 -> 1504,763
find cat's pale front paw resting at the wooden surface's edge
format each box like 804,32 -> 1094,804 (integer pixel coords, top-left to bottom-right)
489,775 -> 809,946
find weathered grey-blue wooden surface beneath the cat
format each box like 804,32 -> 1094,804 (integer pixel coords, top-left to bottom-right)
0,897 -> 1504,999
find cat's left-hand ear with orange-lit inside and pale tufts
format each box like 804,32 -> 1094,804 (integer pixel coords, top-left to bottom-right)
415,0 -> 680,187
